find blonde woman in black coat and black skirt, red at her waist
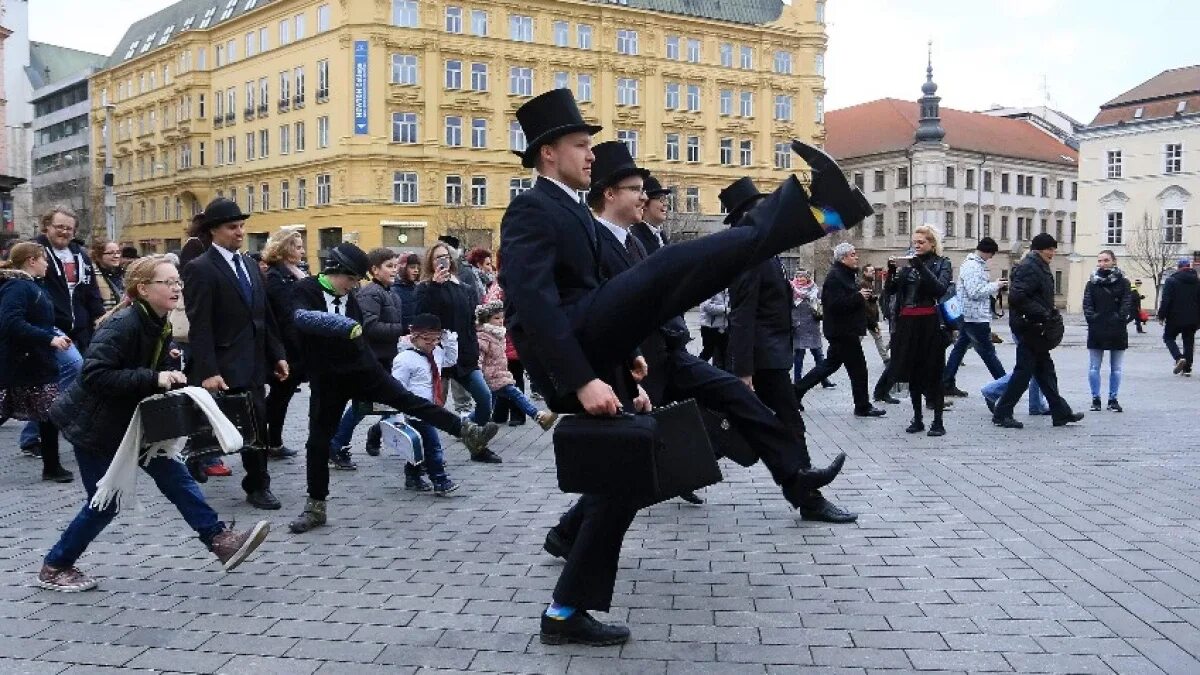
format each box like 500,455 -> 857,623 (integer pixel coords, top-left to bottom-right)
887,225 -> 952,436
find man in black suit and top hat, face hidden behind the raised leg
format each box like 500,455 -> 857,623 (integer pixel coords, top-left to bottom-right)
719,178 -> 858,522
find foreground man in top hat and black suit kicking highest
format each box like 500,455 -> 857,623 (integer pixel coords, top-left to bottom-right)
499,89 -> 870,645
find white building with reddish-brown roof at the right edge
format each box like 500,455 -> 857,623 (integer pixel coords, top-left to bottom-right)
1069,66 -> 1200,310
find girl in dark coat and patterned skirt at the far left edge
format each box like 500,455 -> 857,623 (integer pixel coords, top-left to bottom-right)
0,241 -> 74,483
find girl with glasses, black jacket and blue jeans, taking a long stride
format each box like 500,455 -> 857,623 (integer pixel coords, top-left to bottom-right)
37,256 -> 270,592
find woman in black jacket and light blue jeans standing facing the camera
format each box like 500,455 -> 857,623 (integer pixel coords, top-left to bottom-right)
1084,250 -> 1134,412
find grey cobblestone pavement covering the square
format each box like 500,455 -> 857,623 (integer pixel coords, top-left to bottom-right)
0,317 -> 1200,675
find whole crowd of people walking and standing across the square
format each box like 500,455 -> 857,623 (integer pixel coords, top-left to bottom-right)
0,85 -> 1200,645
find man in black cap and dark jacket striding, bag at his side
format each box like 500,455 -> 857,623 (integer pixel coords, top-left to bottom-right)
991,232 -> 1084,429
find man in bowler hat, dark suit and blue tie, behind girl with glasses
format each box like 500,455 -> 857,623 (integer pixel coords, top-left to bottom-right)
181,197 -> 288,509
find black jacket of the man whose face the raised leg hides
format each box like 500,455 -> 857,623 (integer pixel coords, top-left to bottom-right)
726,257 -> 794,377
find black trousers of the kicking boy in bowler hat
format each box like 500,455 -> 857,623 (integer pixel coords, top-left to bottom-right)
305,363 -> 462,500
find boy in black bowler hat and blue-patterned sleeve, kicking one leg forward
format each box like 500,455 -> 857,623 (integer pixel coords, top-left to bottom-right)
288,243 -> 498,533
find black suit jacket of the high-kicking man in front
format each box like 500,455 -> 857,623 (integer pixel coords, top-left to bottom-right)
499,178 -> 602,396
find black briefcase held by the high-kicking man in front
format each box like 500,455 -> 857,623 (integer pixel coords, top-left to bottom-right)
553,400 -> 721,503
